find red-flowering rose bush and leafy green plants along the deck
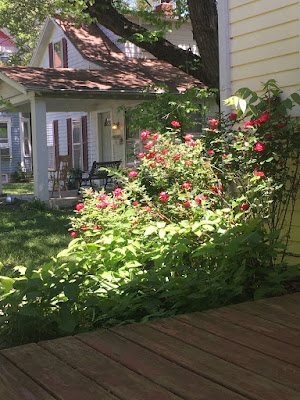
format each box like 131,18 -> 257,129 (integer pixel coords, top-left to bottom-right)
0,83 -> 299,344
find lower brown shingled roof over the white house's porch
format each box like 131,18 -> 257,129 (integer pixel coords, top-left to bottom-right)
0,60 -> 203,92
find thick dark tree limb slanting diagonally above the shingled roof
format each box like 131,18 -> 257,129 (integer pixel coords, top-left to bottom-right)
87,0 -> 218,88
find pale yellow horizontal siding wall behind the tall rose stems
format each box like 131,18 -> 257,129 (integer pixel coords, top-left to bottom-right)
229,0 -> 300,262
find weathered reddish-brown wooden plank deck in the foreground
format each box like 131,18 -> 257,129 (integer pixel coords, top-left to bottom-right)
0,293 -> 300,400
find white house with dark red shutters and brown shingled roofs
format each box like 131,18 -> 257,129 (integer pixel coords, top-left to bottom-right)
0,17 -> 215,200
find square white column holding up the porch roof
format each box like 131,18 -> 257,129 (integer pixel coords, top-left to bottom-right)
31,98 -> 49,201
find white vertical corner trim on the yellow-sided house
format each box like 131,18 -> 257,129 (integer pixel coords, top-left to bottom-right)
218,0 -> 232,112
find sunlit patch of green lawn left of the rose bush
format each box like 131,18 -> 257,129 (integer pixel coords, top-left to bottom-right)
0,200 -> 73,268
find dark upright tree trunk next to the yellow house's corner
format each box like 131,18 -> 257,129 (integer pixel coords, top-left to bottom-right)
187,0 -> 219,88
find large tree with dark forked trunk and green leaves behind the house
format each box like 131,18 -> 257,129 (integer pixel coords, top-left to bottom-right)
0,0 -> 219,87
